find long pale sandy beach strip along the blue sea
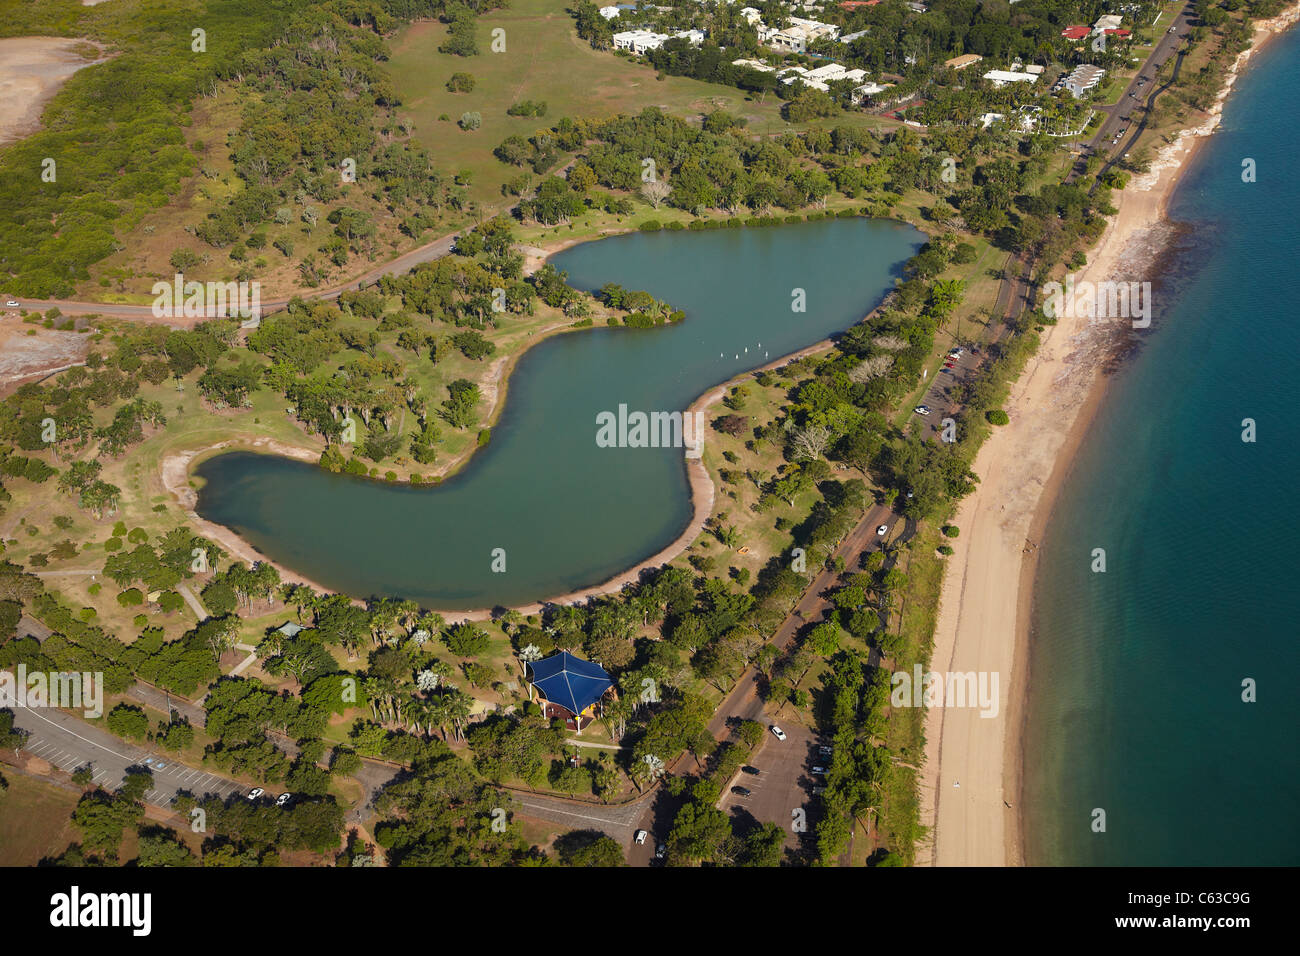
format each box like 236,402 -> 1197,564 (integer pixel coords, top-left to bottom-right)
918,7 -> 1300,866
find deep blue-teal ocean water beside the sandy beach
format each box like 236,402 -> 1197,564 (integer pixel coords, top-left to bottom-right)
1022,30 -> 1300,866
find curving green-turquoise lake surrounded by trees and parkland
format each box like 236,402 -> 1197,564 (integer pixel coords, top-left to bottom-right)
196,219 -> 923,609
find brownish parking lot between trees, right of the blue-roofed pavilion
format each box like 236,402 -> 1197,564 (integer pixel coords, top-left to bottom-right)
718,719 -> 818,849
